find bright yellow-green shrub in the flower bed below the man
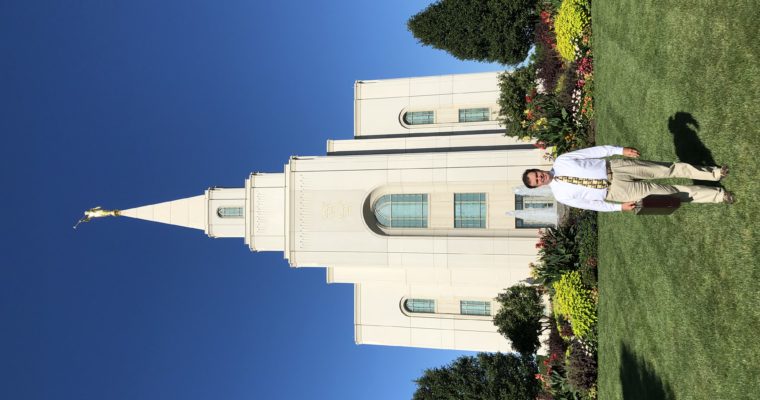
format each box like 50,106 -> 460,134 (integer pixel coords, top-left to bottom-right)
552,271 -> 596,337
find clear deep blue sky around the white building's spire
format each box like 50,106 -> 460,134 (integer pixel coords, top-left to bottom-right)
0,0 -> 510,400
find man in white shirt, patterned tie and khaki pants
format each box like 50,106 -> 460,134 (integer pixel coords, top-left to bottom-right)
523,146 -> 734,211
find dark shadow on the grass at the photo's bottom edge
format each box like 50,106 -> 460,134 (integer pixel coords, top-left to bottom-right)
620,344 -> 675,400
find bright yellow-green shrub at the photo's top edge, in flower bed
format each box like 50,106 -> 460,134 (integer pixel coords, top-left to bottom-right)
554,0 -> 591,61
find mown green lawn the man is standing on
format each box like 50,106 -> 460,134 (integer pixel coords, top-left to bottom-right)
593,0 -> 760,400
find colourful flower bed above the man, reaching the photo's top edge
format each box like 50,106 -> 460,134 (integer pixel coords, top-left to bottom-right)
499,0 -> 594,159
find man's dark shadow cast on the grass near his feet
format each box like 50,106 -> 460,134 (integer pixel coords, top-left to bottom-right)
668,111 -> 720,186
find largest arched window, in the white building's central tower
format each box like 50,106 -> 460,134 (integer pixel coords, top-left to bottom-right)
374,194 -> 428,228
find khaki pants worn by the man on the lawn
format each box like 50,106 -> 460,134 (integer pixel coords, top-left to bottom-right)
605,159 -> 724,203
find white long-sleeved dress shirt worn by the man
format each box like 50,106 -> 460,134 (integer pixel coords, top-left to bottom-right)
549,146 -> 623,212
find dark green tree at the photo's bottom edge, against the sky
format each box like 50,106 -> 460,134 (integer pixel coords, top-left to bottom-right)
413,353 -> 539,400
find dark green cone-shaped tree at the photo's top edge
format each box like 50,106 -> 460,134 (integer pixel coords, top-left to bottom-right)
407,0 -> 537,64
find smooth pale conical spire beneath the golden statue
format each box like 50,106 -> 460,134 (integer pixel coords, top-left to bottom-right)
118,195 -> 208,231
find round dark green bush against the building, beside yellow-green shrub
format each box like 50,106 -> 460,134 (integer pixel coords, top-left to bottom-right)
493,285 -> 550,355
